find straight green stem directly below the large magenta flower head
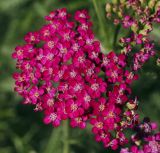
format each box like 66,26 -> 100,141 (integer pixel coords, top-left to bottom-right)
63,120 -> 70,153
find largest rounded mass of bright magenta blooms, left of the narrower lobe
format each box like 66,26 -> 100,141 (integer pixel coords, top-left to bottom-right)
12,9 -> 107,128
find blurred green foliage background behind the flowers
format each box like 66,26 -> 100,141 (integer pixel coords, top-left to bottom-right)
0,0 -> 160,153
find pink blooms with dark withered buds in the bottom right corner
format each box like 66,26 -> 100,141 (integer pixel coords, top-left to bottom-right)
120,118 -> 160,153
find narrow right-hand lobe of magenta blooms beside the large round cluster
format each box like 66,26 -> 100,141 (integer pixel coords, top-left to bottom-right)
90,52 -> 141,150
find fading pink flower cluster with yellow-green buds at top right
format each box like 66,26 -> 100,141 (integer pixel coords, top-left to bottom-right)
106,0 -> 160,71
